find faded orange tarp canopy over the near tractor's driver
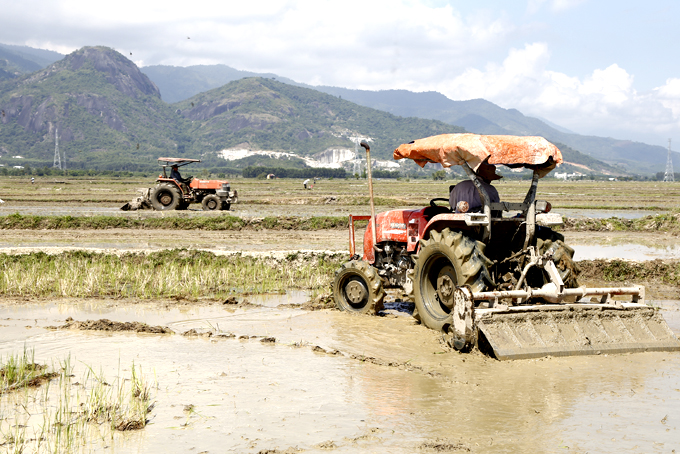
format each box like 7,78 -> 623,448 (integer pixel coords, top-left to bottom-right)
394,134 -> 562,177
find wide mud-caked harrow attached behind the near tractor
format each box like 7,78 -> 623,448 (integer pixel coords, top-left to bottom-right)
449,284 -> 680,360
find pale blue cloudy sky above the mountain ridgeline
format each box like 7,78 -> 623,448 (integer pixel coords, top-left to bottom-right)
0,0 -> 680,149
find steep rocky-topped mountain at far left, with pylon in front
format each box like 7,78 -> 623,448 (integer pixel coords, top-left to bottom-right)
0,47 -> 182,170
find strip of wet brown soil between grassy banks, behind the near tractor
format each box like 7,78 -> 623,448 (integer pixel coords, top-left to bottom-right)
0,224 -> 680,260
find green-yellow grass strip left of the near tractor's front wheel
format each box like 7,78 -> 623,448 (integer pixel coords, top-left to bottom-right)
0,249 -> 347,299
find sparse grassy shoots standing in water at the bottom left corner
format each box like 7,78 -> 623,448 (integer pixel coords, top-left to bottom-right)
0,355 -> 153,453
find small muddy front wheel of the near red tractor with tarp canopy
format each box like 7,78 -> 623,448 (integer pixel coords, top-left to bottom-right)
333,260 -> 385,314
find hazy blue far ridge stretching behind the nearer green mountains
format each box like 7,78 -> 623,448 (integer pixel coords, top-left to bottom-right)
143,65 -> 680,174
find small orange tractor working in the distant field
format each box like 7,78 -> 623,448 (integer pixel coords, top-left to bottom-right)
121,158 -> 238,211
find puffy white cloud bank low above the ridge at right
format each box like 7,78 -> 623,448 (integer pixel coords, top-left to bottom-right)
430,43 -> 680,140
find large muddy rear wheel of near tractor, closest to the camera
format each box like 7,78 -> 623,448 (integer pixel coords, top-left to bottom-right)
413,228 -> 493,331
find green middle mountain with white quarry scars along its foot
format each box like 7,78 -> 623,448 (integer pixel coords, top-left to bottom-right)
173,77 -> 464,159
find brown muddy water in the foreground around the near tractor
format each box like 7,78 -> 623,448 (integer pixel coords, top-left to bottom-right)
0,294 -> 680,453
